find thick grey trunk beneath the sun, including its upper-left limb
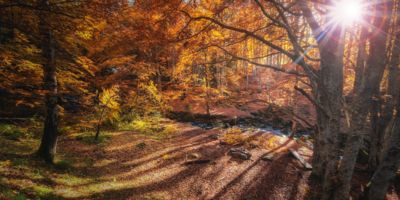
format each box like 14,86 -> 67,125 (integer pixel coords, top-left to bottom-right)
301,1 -> 344,185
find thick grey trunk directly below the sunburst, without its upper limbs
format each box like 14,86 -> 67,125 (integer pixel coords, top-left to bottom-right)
317,27 -> 344,199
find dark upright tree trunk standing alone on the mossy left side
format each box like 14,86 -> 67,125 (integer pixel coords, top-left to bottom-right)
37,0 -> 58,163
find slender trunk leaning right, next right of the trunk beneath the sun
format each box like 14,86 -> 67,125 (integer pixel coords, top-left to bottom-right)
334,2 -> 392,200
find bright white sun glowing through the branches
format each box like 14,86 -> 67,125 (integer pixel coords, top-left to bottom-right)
330,0 -> 364,26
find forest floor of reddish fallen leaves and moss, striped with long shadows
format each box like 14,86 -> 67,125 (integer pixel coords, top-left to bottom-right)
0,121 -> 398,200
